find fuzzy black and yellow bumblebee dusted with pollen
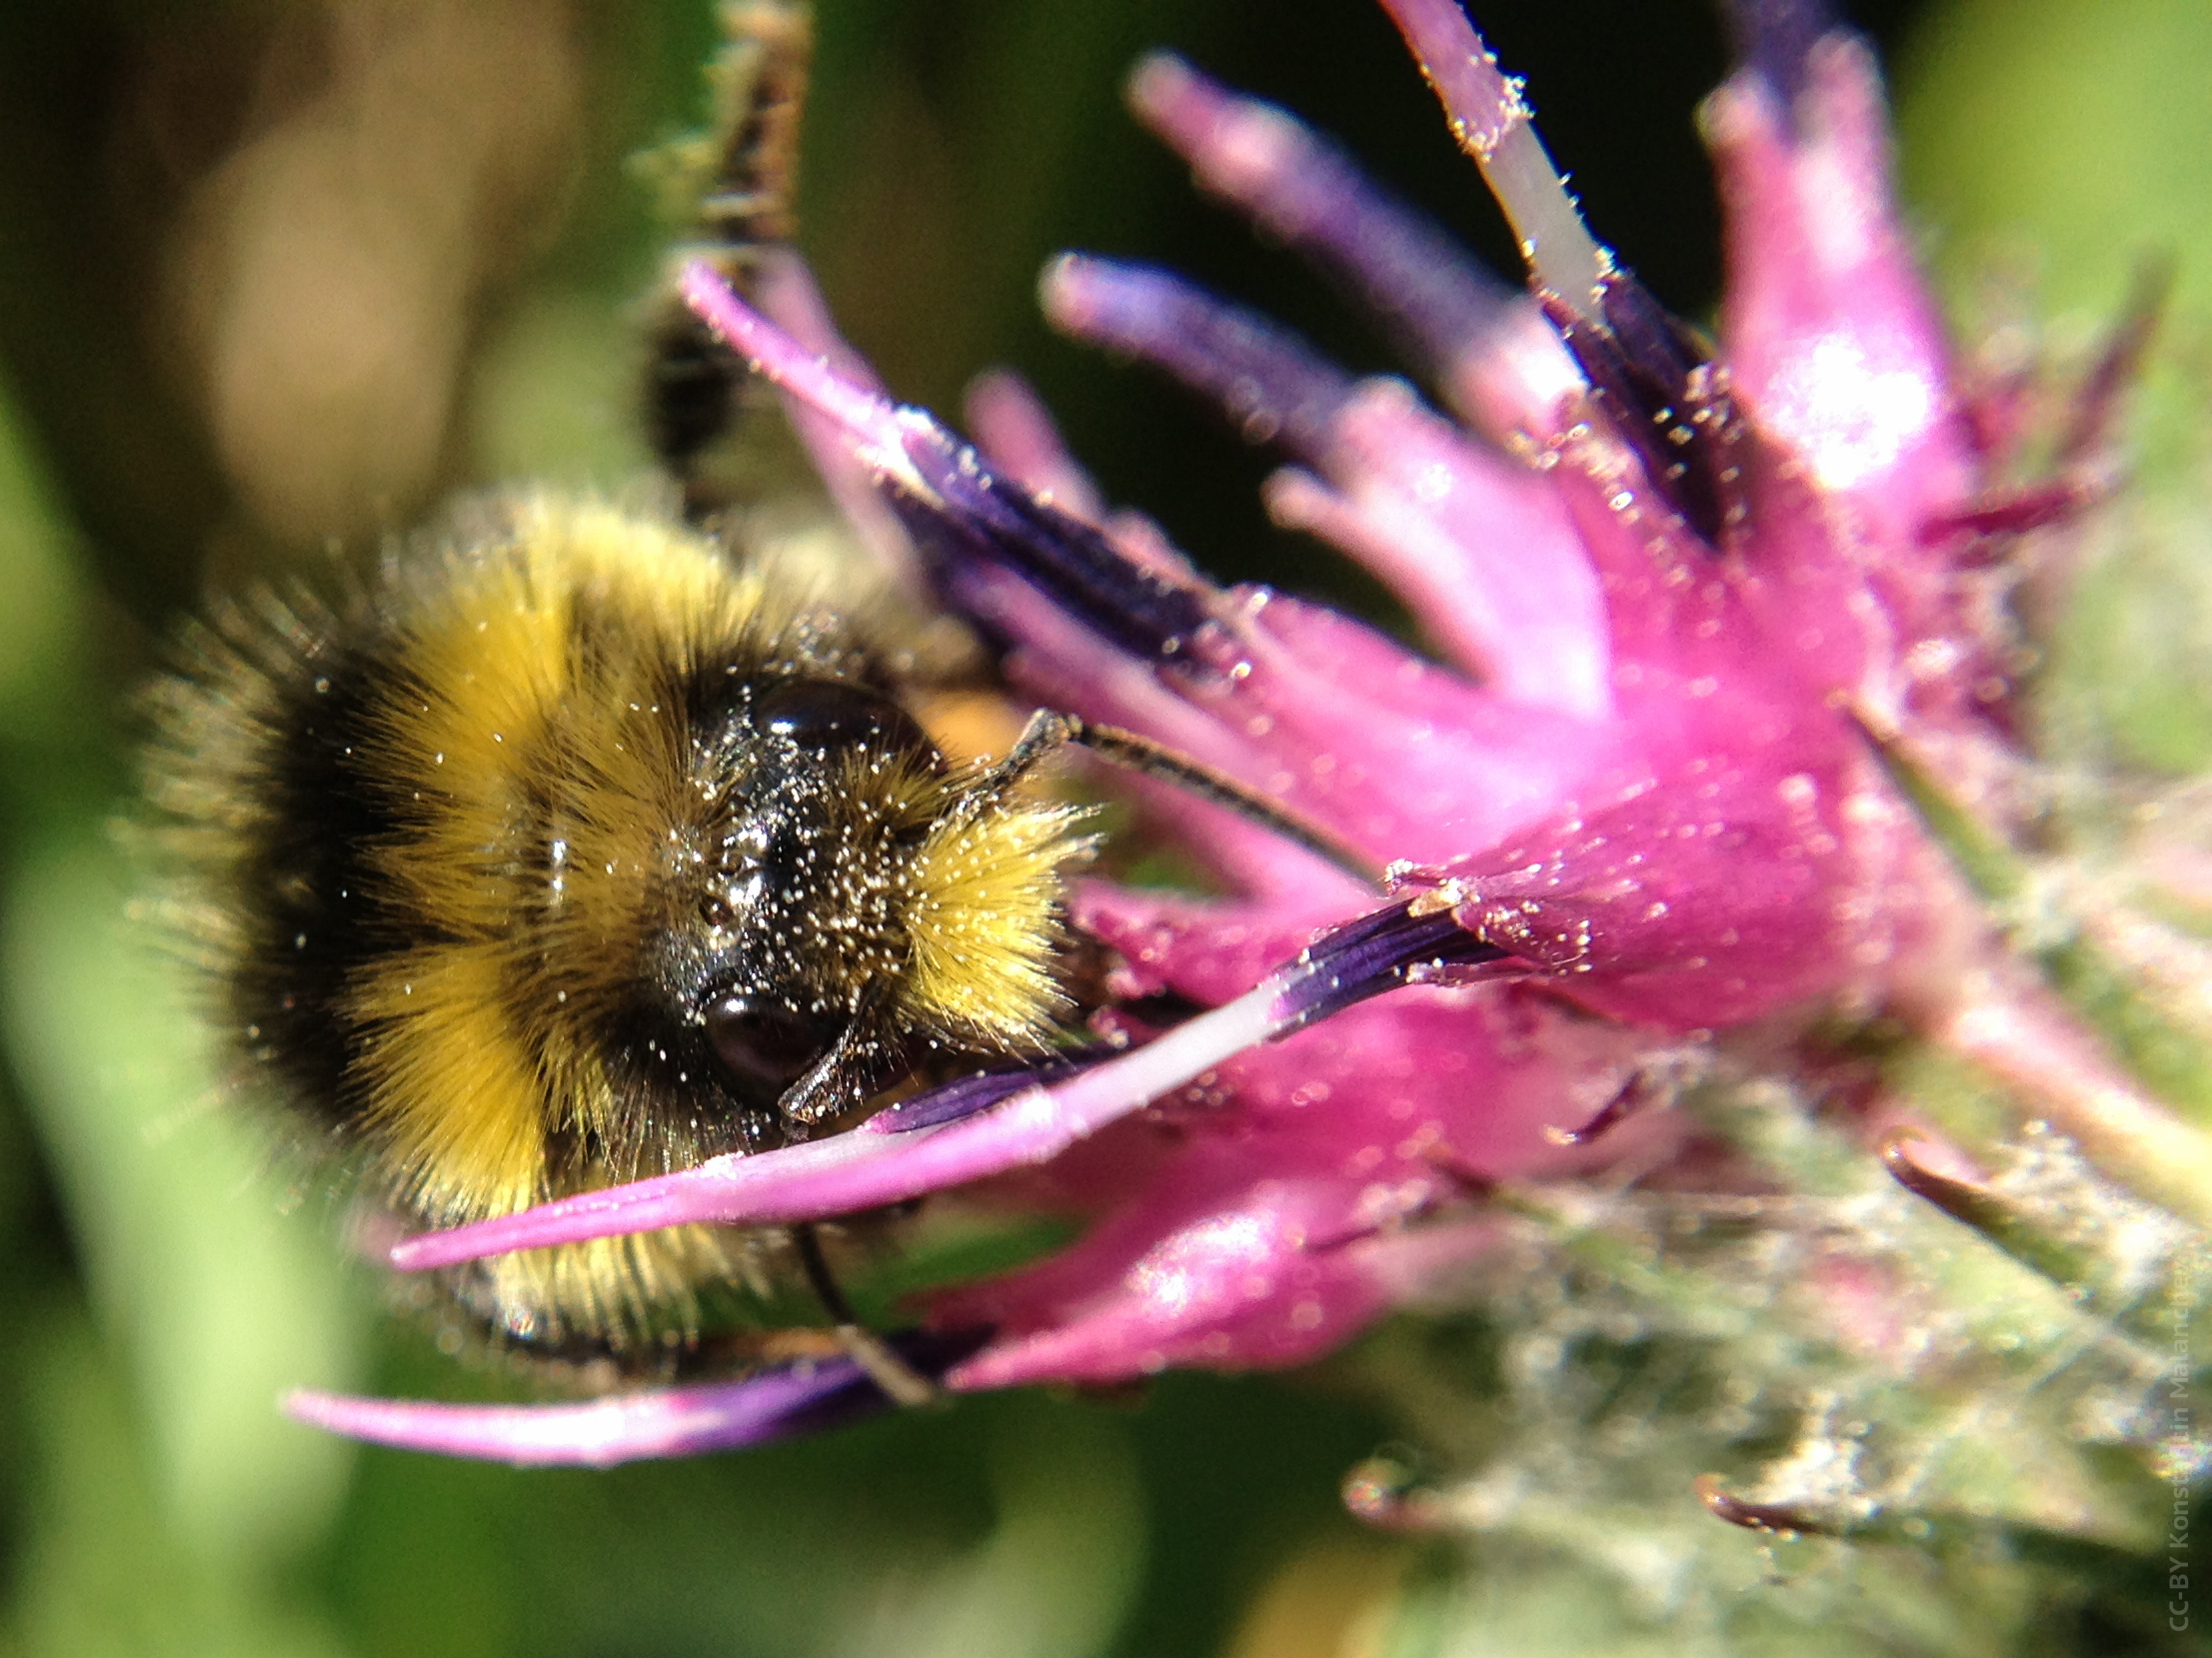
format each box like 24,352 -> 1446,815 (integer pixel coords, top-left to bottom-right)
148,4 -> 1087,1359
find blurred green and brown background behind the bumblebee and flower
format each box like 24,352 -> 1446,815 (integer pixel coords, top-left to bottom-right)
0,0 -> 2212,1658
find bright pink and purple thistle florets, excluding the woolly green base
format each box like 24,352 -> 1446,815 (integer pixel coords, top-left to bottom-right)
294,0 -> 2203,1461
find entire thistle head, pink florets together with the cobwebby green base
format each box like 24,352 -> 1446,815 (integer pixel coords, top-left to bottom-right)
294,0 -> 2212,1541
